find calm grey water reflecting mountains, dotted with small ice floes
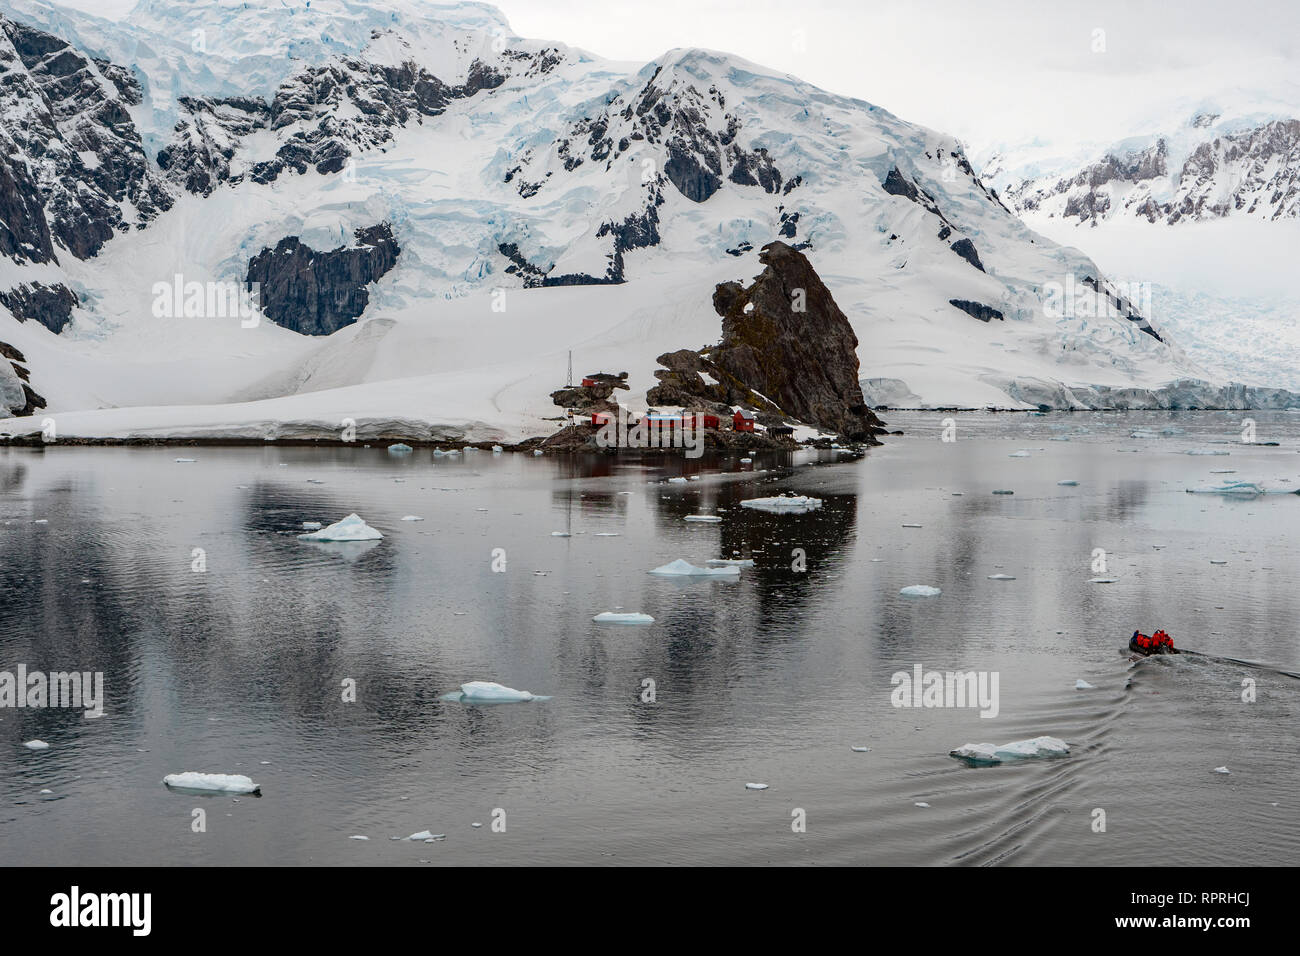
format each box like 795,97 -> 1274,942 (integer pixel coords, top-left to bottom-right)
0,412 -> 1300,865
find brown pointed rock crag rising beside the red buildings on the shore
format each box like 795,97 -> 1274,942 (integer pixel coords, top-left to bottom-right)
646,242 -> 884,442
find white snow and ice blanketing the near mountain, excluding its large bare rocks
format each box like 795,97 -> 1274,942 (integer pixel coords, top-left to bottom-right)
0,0 -> 1248,441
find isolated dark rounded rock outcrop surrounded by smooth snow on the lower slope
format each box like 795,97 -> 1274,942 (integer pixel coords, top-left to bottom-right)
247,222 -> 402,336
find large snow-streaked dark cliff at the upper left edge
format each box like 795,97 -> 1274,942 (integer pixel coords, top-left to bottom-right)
0,17 -> 173,263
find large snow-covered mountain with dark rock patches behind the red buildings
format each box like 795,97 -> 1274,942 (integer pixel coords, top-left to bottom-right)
0,0 -> 1290,438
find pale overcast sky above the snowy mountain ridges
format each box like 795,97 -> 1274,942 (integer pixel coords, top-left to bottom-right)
50,0 -> 1300,152
